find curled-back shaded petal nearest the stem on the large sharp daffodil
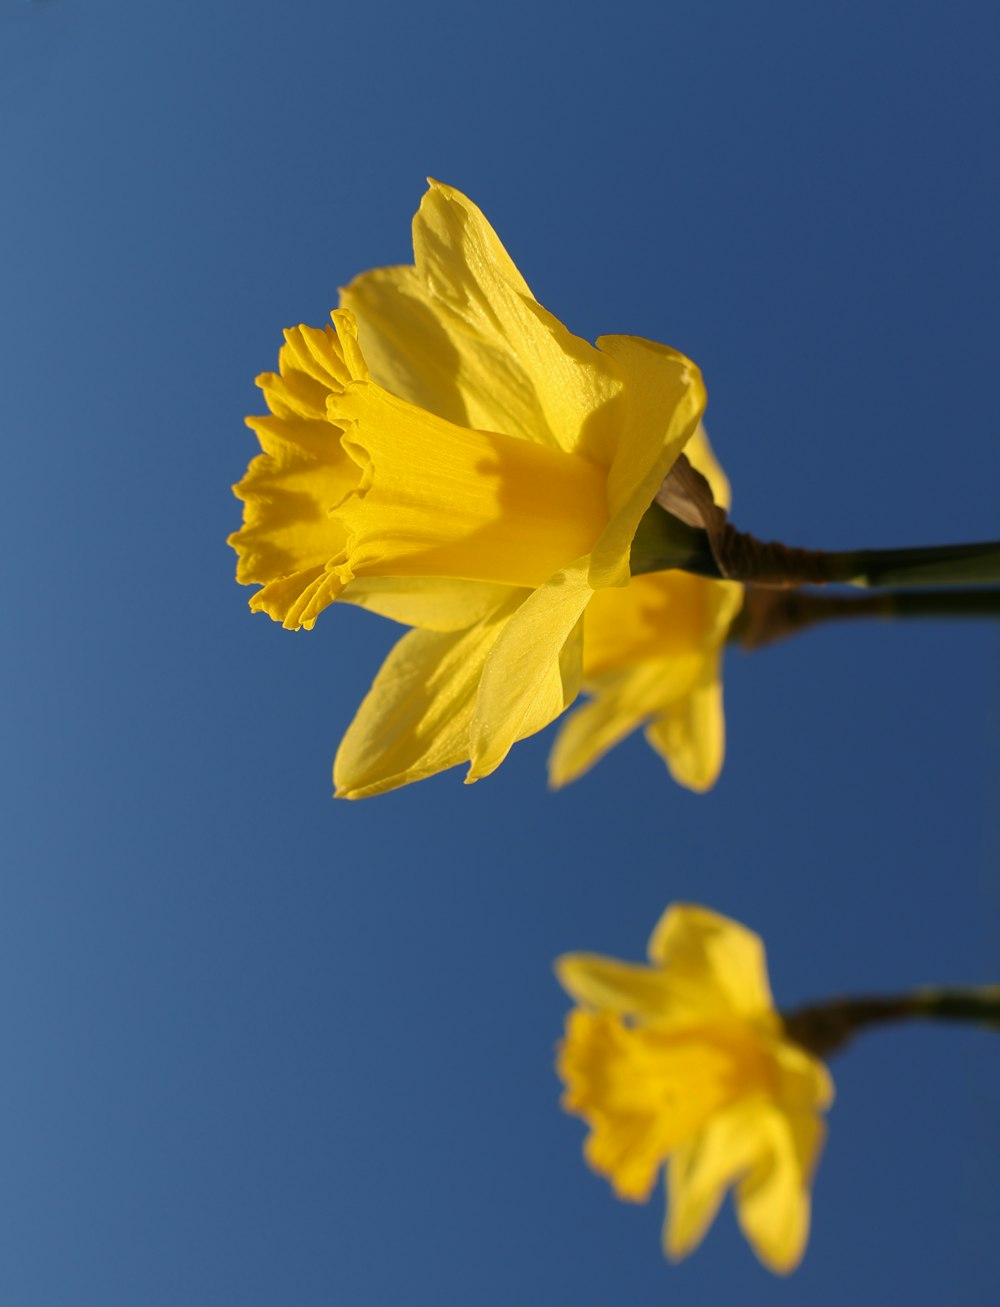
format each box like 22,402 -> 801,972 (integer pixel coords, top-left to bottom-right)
591,336 -> 706,589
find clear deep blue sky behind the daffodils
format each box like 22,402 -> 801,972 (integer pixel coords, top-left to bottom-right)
0,0 -> 1000,1307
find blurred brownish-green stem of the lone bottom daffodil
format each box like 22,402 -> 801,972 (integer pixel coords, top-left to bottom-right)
782,985 -> 1000,1057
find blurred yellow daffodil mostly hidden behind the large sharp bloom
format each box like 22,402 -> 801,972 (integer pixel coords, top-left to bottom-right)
549,427 -> 742,791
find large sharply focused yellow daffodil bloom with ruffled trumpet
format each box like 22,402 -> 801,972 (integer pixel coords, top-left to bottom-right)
231,183 -> 705,797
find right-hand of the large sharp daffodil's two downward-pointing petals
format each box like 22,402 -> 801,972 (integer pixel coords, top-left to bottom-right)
467,558 -> 592,780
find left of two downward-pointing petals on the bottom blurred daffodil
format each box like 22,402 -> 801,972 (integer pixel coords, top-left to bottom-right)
663,1103 -> 766,1261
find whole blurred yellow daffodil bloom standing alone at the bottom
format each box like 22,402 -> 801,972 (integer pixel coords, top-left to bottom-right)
556,904 -> 833,1273
